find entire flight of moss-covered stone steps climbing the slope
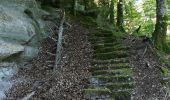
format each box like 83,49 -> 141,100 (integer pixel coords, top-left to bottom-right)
84,31 -> 135,100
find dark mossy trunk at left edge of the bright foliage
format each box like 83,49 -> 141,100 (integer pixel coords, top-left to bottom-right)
117,0 -> 125,32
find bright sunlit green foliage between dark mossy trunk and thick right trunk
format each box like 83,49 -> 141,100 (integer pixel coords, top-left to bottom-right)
124,0 -> 156,37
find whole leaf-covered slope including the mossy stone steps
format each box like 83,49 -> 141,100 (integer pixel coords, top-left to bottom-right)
7,15 -> 166,100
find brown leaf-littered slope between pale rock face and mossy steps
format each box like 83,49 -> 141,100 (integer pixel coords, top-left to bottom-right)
7,18 -> 92,100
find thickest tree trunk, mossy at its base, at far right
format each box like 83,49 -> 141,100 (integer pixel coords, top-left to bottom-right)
152,0 -> 167,49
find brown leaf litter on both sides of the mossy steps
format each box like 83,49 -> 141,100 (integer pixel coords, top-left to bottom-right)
7,16 -> 165,100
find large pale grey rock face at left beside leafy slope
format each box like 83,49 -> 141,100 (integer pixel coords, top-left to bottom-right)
0,0 -> 48,100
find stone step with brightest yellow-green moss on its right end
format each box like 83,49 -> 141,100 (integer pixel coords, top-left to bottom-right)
92,68 -> 133,76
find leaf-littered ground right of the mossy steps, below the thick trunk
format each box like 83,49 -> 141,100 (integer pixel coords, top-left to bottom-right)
125,36 -> 166,100
